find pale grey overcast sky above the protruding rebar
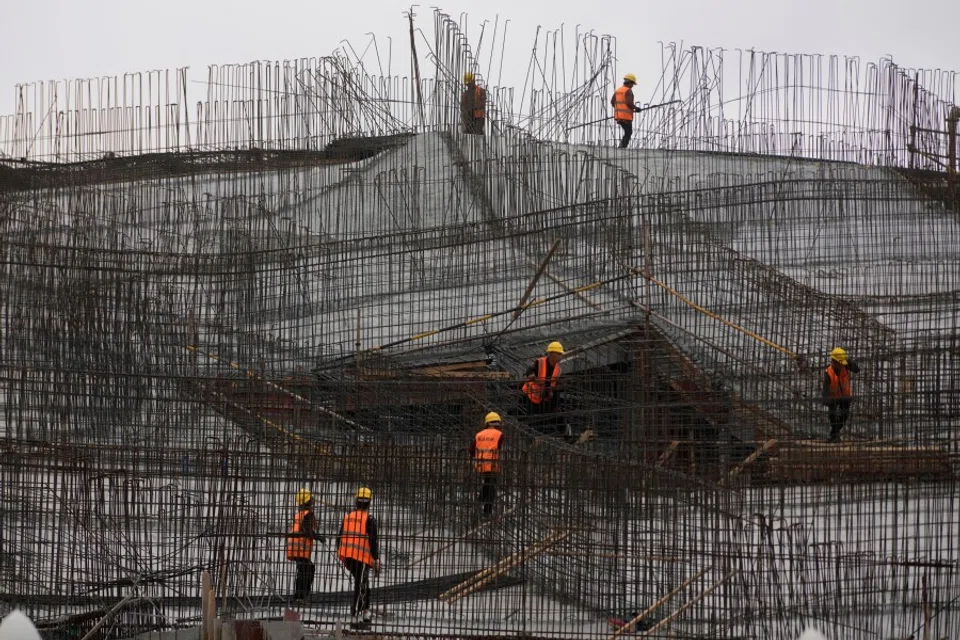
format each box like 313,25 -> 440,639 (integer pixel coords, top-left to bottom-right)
0,0 -> 960,113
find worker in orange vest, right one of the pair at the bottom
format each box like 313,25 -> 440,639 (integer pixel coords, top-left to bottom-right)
337,487 -> 380,629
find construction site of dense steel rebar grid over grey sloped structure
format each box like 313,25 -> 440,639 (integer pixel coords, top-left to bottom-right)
0,10 -> 960,640
